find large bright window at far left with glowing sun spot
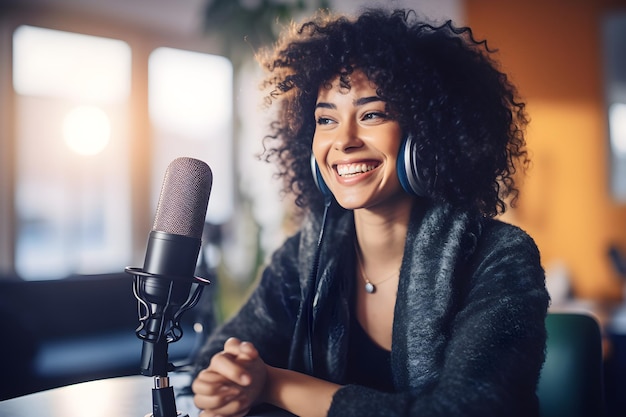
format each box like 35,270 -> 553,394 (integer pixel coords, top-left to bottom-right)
13,26 -> 131,279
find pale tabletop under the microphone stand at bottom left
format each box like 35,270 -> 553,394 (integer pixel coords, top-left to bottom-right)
0,374 -> 293,417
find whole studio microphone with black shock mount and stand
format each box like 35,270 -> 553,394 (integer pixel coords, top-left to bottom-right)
126,157 -> 213,417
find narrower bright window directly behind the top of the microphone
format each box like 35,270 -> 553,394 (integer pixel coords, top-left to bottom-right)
148,48 -> 234,224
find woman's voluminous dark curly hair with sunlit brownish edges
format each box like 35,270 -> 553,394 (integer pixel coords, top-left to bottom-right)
257,9 -> 529,217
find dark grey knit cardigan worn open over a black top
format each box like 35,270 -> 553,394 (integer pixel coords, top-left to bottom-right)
195,200 -> 549,417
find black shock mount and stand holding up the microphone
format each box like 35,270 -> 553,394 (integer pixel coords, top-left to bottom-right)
125,267 -> 210,417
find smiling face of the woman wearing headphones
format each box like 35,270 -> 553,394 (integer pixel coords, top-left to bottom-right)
313,71 -> 408,209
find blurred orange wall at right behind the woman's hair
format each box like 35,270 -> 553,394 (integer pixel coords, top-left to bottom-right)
465,0 -> 626,299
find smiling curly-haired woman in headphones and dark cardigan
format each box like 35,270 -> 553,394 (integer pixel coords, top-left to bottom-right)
192,10 -> 549,417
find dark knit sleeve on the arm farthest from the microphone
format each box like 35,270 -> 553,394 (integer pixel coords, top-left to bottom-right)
328,223 -> 549,417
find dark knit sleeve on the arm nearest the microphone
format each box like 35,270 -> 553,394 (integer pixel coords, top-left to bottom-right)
194,235 -> 301,374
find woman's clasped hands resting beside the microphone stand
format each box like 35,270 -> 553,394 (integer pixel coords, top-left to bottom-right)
191,337 -> 267,417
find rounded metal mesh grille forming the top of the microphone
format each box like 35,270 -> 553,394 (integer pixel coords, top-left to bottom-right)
152,157 -> 213,239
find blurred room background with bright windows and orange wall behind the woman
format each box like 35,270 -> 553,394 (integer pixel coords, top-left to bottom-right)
0,0 -> 626,412
